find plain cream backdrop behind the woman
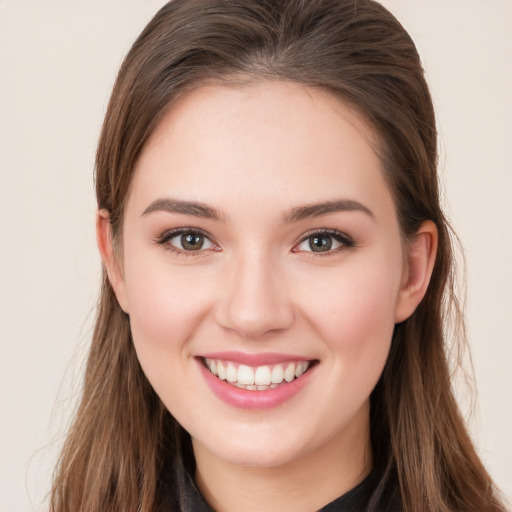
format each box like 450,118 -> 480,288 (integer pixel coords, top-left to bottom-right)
0,0 -> 512,512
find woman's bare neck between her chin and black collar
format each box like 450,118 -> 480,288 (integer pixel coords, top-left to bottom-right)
193,406 -> 372,512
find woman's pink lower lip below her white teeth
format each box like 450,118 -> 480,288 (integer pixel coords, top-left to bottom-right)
198,360 -> 316,411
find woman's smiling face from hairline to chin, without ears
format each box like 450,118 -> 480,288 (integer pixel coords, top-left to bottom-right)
104,82 -> 420,472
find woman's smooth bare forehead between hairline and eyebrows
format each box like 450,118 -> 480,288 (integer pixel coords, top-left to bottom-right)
130,82 -> 389,220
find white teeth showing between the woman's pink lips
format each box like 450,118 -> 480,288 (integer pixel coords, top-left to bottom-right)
202,358 -> 314,391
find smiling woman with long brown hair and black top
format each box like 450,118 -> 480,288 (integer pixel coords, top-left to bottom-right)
52,0 -> 503,511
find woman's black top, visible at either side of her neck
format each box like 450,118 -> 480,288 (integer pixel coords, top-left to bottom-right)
172,460 -> 401,512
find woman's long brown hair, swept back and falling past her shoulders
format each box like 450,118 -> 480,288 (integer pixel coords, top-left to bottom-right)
51,0 -> 503,512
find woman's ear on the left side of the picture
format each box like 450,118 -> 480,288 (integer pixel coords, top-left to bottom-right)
96,210 -> 128,313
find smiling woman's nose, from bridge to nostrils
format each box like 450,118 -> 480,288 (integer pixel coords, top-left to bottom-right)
216,250 -> 294,339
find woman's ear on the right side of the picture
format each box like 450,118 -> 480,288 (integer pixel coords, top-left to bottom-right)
395,220 -> 438,323
